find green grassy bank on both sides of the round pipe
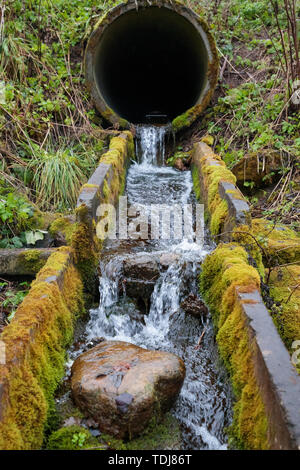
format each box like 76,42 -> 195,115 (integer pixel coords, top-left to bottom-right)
0,0 -> 300,234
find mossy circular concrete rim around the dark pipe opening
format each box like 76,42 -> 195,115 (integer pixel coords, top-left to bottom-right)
84,0 -> 219,132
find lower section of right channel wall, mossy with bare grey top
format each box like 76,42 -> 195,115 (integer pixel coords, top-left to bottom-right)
200,243 -> 300,450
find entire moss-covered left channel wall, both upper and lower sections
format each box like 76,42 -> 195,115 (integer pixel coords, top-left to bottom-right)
0,132 -> 134,450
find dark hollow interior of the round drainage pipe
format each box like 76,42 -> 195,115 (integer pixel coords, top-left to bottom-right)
95,7 -> 207,123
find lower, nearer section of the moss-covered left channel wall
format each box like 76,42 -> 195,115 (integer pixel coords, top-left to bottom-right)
0,247 -> 84,450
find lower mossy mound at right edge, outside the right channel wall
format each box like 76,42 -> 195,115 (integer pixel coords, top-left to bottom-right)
269,265 -> 300,364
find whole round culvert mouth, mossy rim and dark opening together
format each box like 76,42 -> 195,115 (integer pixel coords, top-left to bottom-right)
85,1 -> 218,130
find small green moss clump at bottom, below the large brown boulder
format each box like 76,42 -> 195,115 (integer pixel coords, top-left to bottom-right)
47,425 -> 103,450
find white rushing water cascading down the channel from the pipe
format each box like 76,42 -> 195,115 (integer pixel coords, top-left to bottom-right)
73,126 -> 231,449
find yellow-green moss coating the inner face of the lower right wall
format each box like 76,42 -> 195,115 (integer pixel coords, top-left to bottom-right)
200,243 -> 269,449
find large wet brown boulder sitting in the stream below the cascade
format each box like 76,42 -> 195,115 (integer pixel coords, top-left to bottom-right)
71,341 -> 185,439
